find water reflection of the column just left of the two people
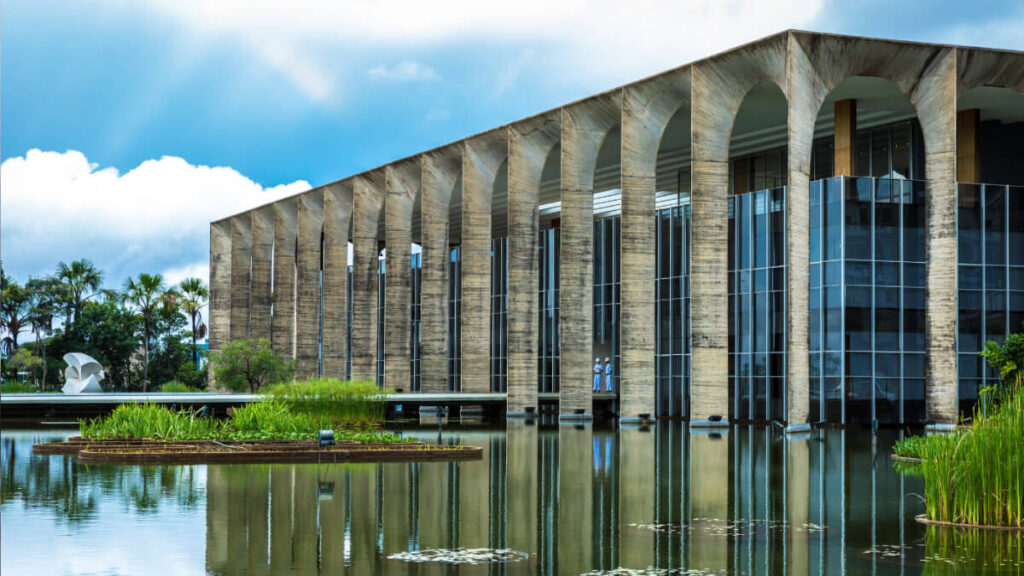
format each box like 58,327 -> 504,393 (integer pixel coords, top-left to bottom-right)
557,423 -> 593,574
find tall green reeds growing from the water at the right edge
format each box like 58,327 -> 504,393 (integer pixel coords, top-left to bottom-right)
896,378 -> 1024,528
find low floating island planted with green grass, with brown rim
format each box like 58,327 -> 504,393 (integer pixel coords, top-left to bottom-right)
33,380 -> 482,464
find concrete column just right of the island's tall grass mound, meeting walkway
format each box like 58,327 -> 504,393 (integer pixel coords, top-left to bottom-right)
384,161 -> 420,390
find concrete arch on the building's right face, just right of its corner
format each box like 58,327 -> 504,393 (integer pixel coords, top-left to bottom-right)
790,33 -> 957,424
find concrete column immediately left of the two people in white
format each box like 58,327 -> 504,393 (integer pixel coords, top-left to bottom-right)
558,92 -> 622,418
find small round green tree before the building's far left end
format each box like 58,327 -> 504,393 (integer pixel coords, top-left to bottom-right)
210,338 -> 295,394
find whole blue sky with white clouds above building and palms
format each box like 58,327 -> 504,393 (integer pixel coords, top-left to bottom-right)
0,0 -> 1024,285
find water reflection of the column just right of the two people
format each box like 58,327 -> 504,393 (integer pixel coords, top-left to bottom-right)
618,427 -> 657,569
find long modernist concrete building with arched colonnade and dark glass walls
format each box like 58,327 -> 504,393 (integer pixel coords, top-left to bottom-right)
210,31 -> 1024,424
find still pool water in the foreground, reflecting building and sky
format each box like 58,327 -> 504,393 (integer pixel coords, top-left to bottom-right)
0,422 -> 1024,576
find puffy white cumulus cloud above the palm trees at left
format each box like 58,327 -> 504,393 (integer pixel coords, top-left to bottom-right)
0,150 -> 309,286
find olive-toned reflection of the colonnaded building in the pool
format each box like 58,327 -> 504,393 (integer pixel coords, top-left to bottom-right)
195,420 -> 1003,576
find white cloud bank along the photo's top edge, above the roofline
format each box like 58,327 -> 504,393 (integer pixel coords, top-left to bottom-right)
134,0 -> 823,99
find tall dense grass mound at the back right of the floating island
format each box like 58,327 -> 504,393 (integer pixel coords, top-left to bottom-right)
267,378 -> 388,427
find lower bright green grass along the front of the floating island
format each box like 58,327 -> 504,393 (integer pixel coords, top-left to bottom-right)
79,398 -> 402,443
